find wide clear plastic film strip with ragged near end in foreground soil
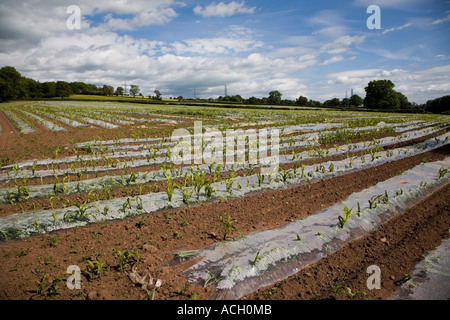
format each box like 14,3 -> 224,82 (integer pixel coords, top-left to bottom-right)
173,158 -> 450,299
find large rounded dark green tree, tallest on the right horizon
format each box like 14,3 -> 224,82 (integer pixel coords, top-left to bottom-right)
364,80 -> 400,109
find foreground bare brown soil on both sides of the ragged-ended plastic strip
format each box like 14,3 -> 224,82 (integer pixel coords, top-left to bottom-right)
0,147 -> 450,300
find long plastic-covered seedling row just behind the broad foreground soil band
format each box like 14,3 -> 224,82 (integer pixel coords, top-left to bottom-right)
0,130 -> 450,238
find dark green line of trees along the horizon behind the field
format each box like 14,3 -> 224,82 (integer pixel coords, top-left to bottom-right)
0,66 -> 450,113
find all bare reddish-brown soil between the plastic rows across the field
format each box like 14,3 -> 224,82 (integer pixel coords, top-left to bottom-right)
0,102 -> 450,301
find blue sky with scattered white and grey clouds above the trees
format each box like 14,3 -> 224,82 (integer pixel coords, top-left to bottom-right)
0,0 -> 450,103
